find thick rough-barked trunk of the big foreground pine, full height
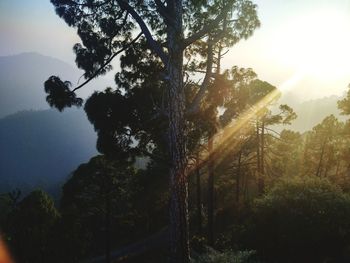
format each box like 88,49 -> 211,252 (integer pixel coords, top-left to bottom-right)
166,0 -> 190,263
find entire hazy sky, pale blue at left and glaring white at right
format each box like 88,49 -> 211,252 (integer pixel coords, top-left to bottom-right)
0,0 -> 350,101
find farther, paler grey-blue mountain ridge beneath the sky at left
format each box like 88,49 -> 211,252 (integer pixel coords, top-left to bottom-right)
0,53 -> 79,118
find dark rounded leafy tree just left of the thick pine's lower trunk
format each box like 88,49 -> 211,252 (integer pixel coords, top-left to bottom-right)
61,156 -> 136,262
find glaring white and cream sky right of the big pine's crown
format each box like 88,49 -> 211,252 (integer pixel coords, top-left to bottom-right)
225,0 -> 350,103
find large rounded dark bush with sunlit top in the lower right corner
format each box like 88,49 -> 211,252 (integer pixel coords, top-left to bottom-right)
249,178 -> 350,262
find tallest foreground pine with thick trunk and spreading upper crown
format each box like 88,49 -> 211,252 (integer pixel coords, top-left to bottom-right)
45,0 -> 259,262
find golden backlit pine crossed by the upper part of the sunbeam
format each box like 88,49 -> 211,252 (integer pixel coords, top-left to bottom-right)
215,70 -> 296,202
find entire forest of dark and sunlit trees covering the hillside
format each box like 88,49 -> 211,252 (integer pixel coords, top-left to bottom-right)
0,0 -> 350,263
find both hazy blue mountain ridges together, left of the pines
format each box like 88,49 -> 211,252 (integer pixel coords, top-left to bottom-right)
0,53 -> 97,196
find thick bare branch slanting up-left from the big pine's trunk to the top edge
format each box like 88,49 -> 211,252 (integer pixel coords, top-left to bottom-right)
117,0 -> 168,65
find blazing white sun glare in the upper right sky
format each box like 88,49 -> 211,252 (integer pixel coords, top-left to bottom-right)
272,8 -> 350,80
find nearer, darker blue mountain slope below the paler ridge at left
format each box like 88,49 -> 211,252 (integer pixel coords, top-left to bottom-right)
0,109 -> 96,196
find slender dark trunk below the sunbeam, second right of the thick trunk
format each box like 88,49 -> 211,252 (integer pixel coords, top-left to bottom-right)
208,135 -> 214,246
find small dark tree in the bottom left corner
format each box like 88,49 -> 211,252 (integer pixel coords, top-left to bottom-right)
5,190 -> 60,263
